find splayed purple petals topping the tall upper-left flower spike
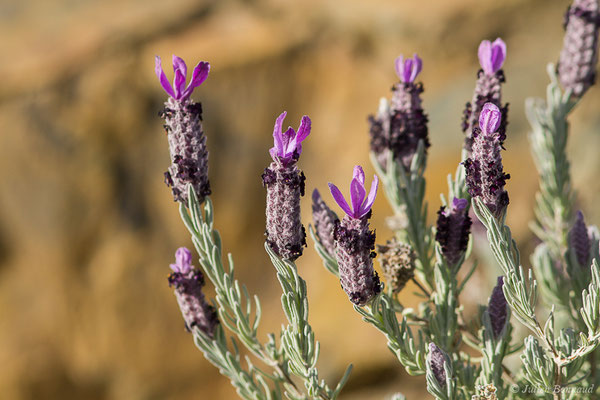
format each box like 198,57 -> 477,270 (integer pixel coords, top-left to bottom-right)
154,55 -> 210,101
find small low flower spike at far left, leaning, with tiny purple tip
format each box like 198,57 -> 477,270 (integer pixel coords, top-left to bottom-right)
169,247 -> 219,338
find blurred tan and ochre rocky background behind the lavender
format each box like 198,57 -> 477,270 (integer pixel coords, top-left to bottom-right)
0,0 -> 600,400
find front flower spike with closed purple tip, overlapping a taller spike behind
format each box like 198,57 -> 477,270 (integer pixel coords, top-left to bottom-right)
463,103 -> 510,217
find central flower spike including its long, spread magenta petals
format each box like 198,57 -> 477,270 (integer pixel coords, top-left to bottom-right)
329,165 -> 381,306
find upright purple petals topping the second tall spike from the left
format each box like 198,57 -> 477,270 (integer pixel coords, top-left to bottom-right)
269,111 -> 311,165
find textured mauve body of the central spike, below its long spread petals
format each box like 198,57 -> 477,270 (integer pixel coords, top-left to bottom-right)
333,215 -> 381,306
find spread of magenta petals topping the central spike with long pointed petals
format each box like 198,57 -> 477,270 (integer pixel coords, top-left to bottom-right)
329,165 -> 379,219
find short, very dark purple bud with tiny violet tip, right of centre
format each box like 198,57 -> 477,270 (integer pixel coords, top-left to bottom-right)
435,198 -> 471,267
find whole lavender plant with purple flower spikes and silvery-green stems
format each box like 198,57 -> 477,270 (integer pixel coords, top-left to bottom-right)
156,0 -> 600,400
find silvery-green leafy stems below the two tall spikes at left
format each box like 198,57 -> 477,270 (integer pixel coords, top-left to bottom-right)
180,187 -> 352,400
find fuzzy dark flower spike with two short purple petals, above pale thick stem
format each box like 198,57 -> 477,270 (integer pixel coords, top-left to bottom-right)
369,54 -> 430,170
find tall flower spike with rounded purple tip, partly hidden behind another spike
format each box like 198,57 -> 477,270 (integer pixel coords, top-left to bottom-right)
462,38 -> 508,156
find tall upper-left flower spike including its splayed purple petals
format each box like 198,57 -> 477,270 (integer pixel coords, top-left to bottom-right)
155,56 -> 211,204
